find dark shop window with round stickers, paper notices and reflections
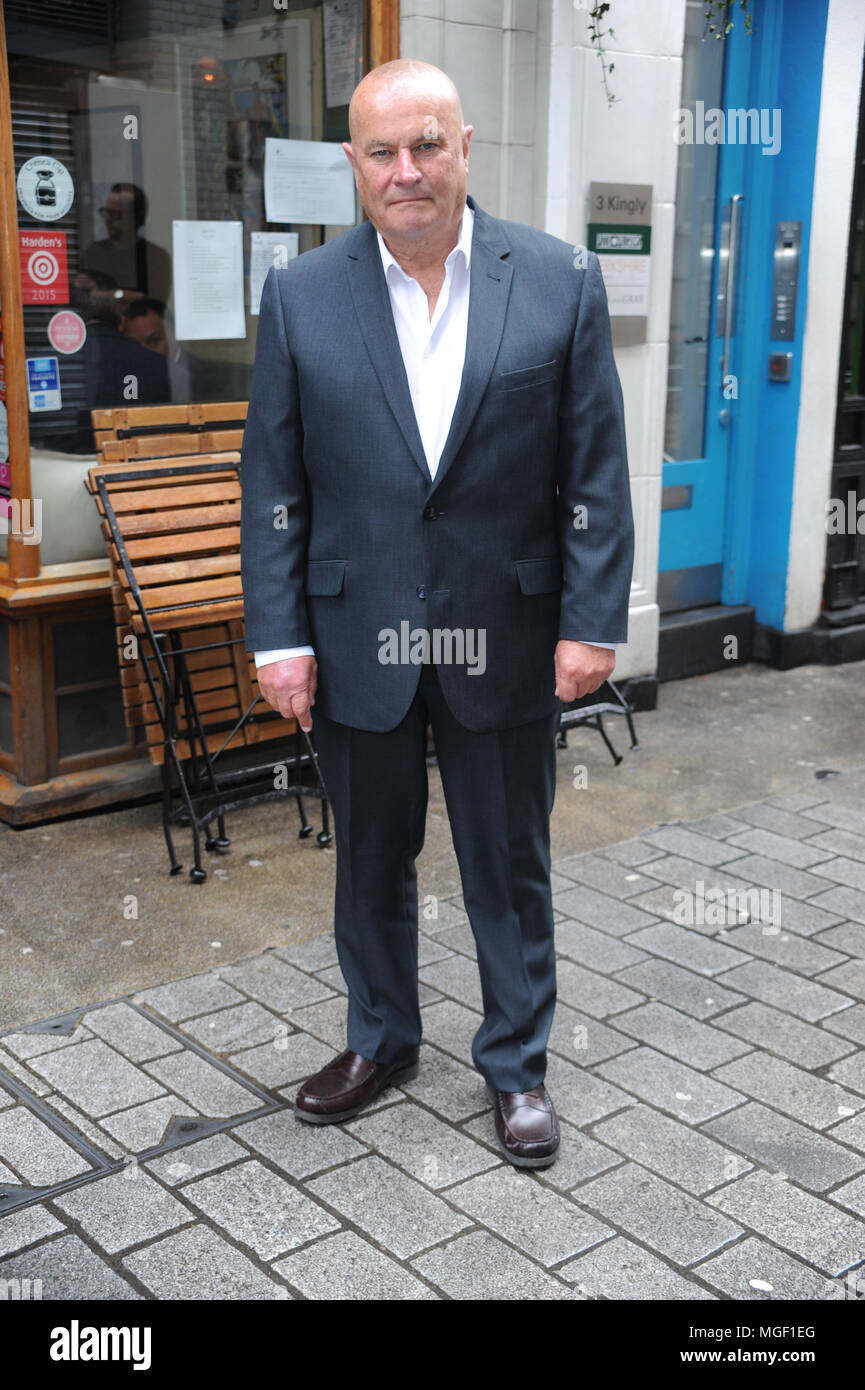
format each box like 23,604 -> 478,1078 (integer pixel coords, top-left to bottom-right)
6,0 -> 364,455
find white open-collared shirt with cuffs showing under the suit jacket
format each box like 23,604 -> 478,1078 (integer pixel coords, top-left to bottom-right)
256,203 -> 615,667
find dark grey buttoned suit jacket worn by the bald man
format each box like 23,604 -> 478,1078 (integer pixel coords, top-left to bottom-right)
241,197 -> 634,731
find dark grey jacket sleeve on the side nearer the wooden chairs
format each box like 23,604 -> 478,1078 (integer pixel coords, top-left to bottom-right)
241,268 -> 312,652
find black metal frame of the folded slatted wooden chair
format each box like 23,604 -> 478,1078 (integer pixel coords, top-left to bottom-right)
93,461 -> 334,883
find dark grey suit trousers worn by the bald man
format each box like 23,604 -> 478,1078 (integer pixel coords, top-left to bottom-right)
313,666 -> 559,1091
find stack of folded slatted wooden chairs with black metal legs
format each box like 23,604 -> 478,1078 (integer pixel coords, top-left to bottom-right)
86,402 -> 332,883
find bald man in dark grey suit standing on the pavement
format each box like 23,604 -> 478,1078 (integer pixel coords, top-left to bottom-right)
242,60 -> 633,1168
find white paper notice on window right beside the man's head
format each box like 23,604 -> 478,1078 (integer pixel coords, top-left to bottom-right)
264,139 -> 356,227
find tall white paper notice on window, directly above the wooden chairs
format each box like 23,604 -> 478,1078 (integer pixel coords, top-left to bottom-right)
174,222 -> 246,342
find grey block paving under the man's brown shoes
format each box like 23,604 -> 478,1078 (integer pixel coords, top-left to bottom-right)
0,765 -> 865,1301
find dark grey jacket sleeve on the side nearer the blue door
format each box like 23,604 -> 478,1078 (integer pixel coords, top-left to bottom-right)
558,252 -> 634,642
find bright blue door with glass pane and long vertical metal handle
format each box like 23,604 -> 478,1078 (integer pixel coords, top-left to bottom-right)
658,9 -> 754,612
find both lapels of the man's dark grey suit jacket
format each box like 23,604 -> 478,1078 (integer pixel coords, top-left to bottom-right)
348,197 -> 513,492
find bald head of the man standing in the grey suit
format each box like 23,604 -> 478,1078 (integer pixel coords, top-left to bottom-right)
342,58 -> 471,259
